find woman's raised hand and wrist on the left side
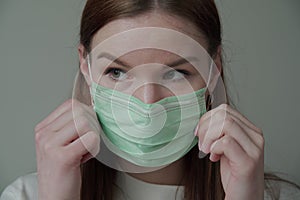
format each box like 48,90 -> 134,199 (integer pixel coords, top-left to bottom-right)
35,99 -> 100,200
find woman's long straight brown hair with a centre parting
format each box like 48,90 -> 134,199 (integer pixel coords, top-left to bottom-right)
75,0 -> 298,200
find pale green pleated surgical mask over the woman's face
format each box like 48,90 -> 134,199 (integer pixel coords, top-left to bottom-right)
91,82 -> 207,167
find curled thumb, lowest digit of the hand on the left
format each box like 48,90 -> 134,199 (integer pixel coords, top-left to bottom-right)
66,131 -> 100,159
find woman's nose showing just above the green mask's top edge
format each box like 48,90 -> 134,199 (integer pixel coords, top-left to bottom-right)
133,83 -> 174,104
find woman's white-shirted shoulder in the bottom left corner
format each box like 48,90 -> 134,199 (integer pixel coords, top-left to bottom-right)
0,173 -> 37,200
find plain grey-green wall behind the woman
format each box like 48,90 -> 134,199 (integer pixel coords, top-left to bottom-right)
0,0 -> 300,193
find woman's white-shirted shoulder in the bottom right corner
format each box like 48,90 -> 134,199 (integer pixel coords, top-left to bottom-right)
265,180 -> 300,200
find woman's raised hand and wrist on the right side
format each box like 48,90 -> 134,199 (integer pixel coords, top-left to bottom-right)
195,104 -> 264,200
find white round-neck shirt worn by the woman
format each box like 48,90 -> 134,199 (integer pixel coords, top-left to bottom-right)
0,172 -> 300,200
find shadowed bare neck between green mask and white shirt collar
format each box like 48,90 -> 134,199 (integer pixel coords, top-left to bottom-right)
128,157 -> 185,185
